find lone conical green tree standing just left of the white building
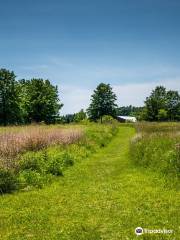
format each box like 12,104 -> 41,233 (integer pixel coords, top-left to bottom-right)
87,83 -> 117,122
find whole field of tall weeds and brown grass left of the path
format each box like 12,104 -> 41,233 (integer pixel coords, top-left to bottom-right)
0,124 -> 116,193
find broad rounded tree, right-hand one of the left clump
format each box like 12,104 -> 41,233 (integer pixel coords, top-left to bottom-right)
21,78 -> 63,123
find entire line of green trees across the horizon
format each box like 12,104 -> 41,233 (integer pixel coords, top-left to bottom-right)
0,69 -> 180,126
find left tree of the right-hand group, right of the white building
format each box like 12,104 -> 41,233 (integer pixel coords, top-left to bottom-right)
145,86 -> 167,121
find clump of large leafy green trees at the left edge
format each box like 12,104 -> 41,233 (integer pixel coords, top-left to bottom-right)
0,69 -> 62,125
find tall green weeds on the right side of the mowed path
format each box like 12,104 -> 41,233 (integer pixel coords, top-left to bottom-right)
130,122 -> 180,185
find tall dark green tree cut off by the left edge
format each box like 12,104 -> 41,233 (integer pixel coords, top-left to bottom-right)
0,69 -> 22,126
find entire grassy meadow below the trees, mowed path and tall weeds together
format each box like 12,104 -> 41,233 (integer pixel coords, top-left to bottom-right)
0,123 -> 180,240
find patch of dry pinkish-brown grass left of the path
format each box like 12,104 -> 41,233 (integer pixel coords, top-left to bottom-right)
0,126 -> 83,168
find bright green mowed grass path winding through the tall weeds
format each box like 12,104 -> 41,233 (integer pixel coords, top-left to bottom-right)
0,127 -> 180,240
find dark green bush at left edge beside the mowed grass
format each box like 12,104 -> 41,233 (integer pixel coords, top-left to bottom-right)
0,168 -> 17,194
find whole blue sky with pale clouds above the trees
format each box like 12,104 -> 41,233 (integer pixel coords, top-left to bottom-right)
0,0 -> 180,114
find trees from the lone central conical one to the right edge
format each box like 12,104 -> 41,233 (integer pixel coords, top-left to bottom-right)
87,83 -> 180,121
